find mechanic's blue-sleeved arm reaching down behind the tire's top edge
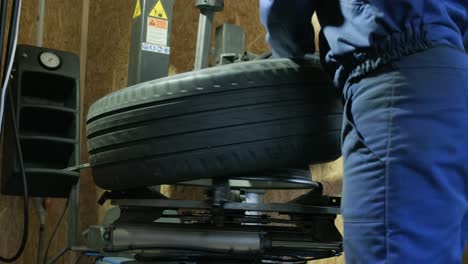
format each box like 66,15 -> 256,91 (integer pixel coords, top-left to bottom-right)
260,0 -> 317,58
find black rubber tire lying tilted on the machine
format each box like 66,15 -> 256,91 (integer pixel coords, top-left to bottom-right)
87,59 -> 342,190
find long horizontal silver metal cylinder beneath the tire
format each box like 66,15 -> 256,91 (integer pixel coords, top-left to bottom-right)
87,225 -> 342,256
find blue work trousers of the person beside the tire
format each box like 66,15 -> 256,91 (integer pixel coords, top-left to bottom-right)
342,47 -> 468,264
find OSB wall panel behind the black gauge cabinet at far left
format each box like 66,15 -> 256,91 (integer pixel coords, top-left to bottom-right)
0,0 -> 82,264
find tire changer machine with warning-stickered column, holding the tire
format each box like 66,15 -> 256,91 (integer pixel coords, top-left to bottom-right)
0,0 -> 342,264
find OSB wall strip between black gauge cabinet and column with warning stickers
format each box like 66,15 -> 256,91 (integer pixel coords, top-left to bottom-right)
80,0 -> 134,227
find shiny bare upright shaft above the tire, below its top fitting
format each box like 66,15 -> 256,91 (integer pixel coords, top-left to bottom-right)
195,10 -> 214,70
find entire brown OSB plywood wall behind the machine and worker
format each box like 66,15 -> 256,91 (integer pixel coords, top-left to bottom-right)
0,0 -> 464,264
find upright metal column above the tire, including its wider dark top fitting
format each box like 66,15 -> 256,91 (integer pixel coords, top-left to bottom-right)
194,0 -> 224,70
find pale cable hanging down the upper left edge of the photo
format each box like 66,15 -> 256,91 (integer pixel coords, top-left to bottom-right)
0,0 -> 21,134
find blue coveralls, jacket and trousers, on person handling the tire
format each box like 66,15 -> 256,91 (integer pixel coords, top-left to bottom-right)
260,0 -> 468,264
